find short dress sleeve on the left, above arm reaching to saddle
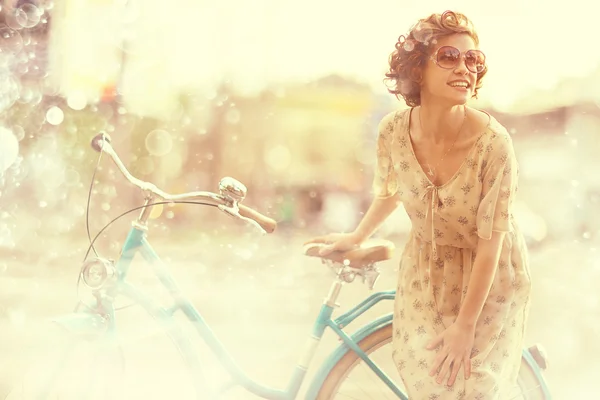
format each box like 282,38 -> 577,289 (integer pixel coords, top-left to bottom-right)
373,113 -> 398,199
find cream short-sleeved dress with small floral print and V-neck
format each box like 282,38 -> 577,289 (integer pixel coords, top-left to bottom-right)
374,110 -> 530,400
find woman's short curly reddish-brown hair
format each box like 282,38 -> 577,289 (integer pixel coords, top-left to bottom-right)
384,11 -> 487,107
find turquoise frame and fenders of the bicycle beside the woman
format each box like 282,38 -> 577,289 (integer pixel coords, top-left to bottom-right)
51,222 -> 550,400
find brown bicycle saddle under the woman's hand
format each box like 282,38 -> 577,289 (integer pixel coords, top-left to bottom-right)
304,239 -> 394,268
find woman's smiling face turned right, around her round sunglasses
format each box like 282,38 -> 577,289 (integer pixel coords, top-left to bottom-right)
421,34 -> 481,106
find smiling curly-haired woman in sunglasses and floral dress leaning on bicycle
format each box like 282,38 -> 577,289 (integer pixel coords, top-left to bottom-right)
310,11 -> 530,399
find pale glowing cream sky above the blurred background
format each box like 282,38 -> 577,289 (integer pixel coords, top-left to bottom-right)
55,0 -> 600,115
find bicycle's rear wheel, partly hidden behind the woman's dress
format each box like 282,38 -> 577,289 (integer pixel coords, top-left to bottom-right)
317,322 -> 545,400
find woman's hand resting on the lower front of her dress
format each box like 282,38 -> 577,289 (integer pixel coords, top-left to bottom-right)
427,322 -> 475,386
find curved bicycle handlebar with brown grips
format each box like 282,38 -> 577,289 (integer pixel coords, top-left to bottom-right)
91,133 -> 277,233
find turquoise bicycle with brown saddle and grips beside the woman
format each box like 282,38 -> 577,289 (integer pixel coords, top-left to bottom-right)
1,133 -> 551,400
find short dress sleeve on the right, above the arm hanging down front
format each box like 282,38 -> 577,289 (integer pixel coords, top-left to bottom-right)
477,133 -> 519,240
